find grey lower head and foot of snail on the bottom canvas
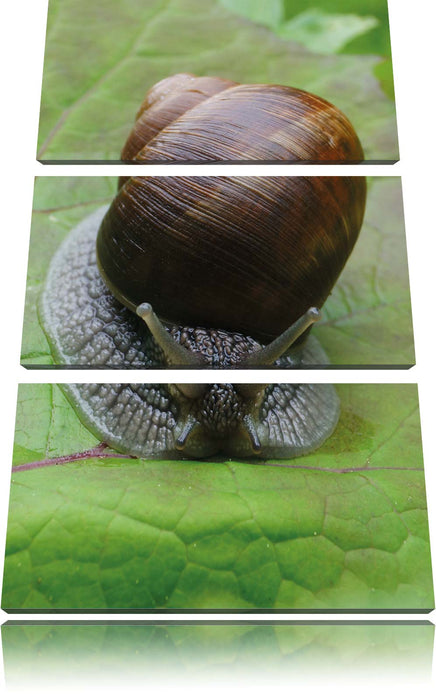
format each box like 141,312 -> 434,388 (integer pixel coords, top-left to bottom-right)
63,384 -> 339,459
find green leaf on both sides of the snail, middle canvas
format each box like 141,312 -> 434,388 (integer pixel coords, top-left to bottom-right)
21,177 -> 415,366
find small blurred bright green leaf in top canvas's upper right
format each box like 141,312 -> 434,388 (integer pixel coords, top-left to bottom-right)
278,9 -> 378,53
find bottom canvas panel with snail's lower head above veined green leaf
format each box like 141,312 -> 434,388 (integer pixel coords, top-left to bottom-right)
2,384 -> 434,613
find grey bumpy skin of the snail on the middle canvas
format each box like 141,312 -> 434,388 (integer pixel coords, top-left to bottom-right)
39,208 -> 328,369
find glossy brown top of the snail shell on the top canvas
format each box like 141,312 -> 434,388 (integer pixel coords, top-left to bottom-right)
121,73 -> 363,163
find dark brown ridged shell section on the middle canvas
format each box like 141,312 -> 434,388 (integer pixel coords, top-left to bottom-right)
97,177 -> 366,342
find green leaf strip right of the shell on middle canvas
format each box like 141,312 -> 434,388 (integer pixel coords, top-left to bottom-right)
314,178 -> 414,366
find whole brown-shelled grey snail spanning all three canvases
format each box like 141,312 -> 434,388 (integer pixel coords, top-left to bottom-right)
40,74 -> 366,458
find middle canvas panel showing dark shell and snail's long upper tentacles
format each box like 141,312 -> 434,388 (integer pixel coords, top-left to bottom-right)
21,176 -> 415,369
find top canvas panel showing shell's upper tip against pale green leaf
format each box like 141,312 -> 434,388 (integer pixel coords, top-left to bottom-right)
37,0 -> 399,163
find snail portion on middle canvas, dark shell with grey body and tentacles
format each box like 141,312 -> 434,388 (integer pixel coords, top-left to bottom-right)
39,177 -> 366,368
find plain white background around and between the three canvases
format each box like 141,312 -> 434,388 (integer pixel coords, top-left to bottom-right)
0,0 -> 436,697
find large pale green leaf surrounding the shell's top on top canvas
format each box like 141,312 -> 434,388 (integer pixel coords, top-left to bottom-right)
38,0 -> 398,161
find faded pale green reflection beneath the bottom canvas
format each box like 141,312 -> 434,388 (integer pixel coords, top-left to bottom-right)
2,620 -> 434,697
